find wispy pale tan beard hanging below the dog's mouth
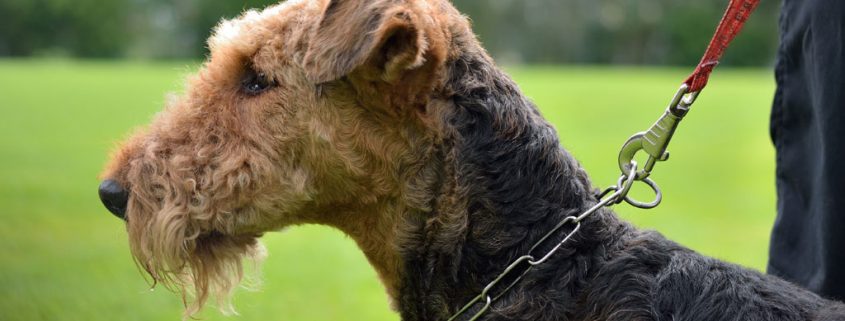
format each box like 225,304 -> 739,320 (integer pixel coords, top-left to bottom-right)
127,194 -> 266,318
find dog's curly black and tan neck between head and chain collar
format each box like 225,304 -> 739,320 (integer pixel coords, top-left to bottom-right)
390,47 -> 622,320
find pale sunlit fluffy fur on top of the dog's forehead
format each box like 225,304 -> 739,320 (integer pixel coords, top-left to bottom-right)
208,0 -> 324,56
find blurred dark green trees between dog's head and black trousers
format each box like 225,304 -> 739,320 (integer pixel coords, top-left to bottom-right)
453,0 -> 779,65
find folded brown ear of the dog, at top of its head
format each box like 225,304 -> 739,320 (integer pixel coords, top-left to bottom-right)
303,0 -> 428,83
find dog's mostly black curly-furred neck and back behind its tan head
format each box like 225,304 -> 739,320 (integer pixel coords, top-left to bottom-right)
399,43 -> 845,321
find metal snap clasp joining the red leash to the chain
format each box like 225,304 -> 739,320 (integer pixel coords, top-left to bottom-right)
619,84 -> 699,180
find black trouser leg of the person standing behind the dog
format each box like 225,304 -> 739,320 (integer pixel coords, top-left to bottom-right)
768,0 -> 845,300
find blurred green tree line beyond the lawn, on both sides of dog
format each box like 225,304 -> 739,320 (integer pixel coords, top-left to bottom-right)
0,0 -> 779,66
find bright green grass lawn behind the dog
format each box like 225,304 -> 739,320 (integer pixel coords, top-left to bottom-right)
0,61 -> 775,321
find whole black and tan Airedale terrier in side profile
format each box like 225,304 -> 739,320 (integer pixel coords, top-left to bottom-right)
99,0 -> 845,320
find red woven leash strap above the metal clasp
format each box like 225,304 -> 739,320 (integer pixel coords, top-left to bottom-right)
684,0 -> 760,92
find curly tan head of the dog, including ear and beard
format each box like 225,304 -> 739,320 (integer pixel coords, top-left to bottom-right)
100,0 -> 465,313
